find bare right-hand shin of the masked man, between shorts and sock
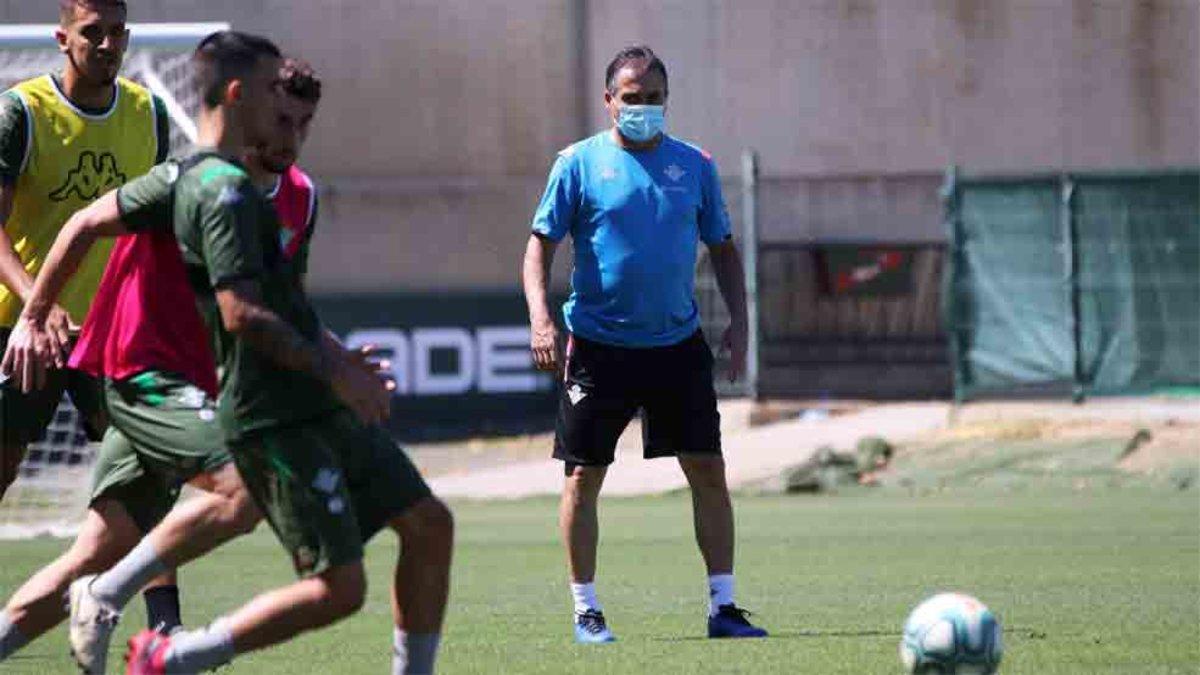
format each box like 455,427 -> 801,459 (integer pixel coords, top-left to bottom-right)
679,455 -> 733,577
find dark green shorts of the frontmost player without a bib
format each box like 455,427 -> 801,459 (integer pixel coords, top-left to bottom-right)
232,410 -> 432,577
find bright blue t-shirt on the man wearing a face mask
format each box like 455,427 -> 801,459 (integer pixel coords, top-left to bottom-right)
533,130 -> 730,347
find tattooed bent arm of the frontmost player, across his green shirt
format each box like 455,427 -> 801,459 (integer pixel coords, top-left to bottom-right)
216,279 -> 391,424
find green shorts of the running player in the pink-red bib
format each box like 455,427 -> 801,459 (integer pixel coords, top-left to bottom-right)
91,371 -> 233,532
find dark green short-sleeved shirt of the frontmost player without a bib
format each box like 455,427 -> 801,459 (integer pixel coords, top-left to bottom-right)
118,151 -> 340,441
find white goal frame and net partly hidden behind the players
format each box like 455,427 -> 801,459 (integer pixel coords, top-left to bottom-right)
0,23 -> 229,539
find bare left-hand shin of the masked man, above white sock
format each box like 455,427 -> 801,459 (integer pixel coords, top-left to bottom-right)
558,466 -> 608,584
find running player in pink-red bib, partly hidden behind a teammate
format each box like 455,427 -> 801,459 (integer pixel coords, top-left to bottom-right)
0,53 -> 338,673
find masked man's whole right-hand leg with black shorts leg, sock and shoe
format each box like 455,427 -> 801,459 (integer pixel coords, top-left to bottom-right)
642,331 -> 766,638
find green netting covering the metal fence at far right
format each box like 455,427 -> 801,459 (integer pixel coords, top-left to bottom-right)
943,169 -> 1200,400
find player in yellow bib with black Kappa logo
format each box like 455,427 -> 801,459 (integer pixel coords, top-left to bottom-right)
0,0 -> 179,648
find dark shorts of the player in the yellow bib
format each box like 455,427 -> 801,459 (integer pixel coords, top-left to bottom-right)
0,328 -> 106,447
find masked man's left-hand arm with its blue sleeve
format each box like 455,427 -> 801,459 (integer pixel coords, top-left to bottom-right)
521,151 -> 573,371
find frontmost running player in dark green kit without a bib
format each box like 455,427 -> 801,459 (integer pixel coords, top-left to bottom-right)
5,31 -> 452,674
